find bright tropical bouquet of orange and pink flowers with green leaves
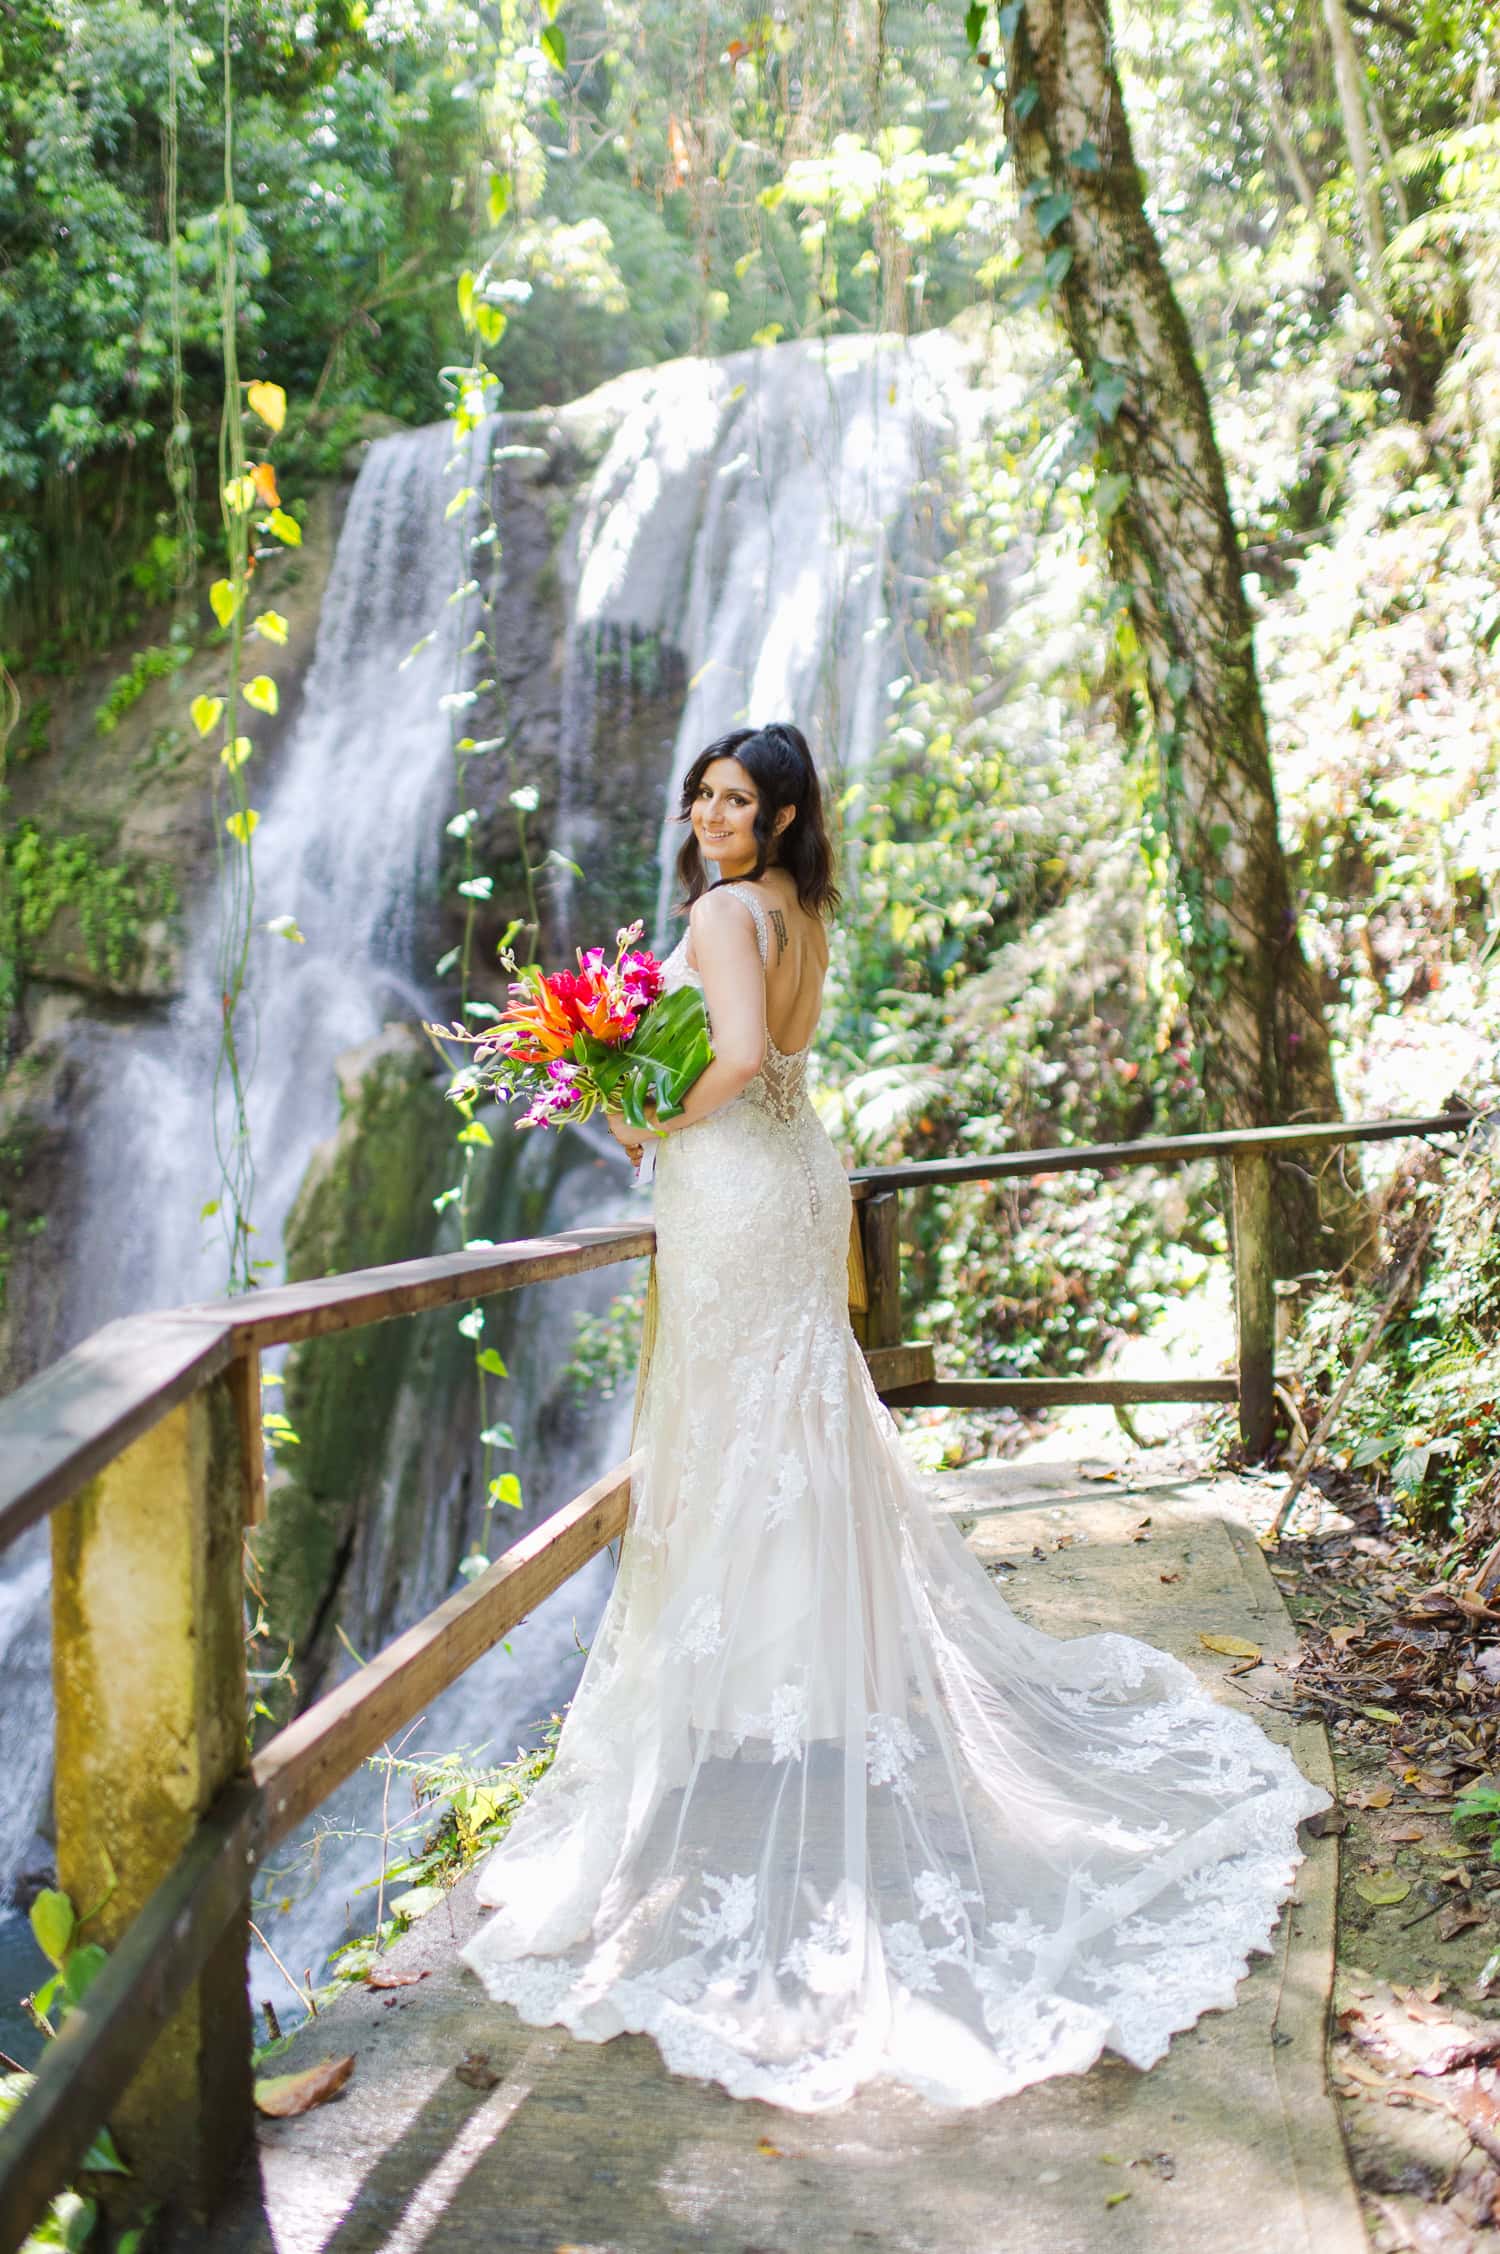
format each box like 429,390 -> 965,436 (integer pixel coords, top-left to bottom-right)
424,924 -> 713,1127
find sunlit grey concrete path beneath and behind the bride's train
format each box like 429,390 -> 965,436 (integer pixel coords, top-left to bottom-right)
212,1463 -> 1367,2254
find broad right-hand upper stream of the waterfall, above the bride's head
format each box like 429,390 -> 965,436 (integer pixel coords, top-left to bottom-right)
550,329 -> 986,935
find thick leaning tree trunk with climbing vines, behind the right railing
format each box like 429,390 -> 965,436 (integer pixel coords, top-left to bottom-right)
1002,0 -> 1365,1274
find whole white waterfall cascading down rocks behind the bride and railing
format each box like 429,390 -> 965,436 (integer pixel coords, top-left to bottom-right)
0,334 -> 983,2046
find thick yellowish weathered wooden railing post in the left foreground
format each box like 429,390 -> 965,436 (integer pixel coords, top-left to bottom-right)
52,1370 -> 259,2222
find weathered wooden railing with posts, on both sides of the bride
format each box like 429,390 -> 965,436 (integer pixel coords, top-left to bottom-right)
0,1113 -> 1471,2254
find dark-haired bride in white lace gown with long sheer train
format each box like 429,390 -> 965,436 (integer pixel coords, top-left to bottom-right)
462,724 -> 1329,2110
